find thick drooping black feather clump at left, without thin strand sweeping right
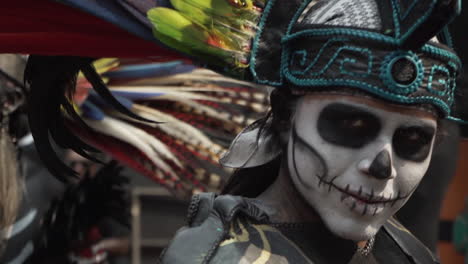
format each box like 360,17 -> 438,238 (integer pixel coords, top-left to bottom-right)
25,55 -> 93,182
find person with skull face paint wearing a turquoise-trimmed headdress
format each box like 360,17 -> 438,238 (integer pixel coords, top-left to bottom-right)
161,0 -> 460,263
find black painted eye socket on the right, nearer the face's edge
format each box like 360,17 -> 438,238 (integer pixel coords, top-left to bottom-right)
392,126 -> 435,162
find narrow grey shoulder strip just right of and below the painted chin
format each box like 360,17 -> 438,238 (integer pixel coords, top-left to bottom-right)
384,218 -> 440,264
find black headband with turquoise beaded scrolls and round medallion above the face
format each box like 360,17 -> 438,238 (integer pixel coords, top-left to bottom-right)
282,34 -> 461,116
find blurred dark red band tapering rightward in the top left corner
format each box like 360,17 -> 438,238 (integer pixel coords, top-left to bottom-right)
0,0 -> 180,58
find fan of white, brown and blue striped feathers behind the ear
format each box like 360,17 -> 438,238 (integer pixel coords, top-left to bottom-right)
68,60 -> 268,197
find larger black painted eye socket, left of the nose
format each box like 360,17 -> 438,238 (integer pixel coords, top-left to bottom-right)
317,103 -> 381,148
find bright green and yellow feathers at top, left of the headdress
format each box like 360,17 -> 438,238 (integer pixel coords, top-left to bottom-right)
147,0 -> 261,75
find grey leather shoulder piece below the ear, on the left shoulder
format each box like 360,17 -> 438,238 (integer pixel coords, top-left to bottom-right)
160,193 -> 267,264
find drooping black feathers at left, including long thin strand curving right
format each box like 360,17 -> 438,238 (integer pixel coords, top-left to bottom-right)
25,55 -> 154,182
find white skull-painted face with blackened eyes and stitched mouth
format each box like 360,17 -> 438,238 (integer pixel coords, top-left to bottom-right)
287,95 -> 437,241
